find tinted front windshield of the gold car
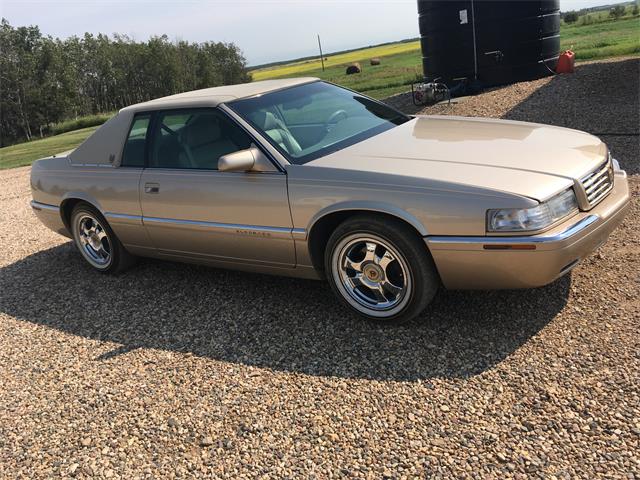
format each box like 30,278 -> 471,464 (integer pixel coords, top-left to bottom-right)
228,82 -> 409,164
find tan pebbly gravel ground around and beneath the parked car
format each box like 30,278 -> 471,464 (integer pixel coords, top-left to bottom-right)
0,55 -> 640,479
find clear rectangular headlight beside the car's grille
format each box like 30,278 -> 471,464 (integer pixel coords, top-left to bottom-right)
487,188 -> 578,232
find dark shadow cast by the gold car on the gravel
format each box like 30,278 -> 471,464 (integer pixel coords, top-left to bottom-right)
0,242 -> 570,381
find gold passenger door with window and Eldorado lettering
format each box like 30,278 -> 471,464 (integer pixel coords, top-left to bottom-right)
140,108 -> 295,267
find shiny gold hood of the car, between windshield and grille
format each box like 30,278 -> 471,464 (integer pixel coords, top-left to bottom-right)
307,116 -> 607,201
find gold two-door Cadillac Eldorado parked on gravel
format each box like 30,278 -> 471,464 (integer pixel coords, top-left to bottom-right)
31,78 -> 629,322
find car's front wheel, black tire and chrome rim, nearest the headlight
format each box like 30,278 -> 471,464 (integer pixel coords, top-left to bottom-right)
324,215 -> 440,323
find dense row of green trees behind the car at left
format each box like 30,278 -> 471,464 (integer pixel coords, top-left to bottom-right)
0,18 -> 251,146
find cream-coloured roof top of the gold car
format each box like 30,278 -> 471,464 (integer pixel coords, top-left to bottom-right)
120,77 -> 318,112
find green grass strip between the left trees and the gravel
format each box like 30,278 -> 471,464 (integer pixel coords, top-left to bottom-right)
0,127 -> 98,169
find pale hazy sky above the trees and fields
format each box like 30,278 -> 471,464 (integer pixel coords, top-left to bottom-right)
0,0 -> 617,65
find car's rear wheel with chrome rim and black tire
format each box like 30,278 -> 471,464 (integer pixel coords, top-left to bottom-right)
70,203 -> 135,273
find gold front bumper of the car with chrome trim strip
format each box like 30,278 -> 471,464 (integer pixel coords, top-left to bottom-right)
424,171 -> 630,290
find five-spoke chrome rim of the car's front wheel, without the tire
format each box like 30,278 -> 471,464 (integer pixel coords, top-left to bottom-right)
332,234 -> 413,318
